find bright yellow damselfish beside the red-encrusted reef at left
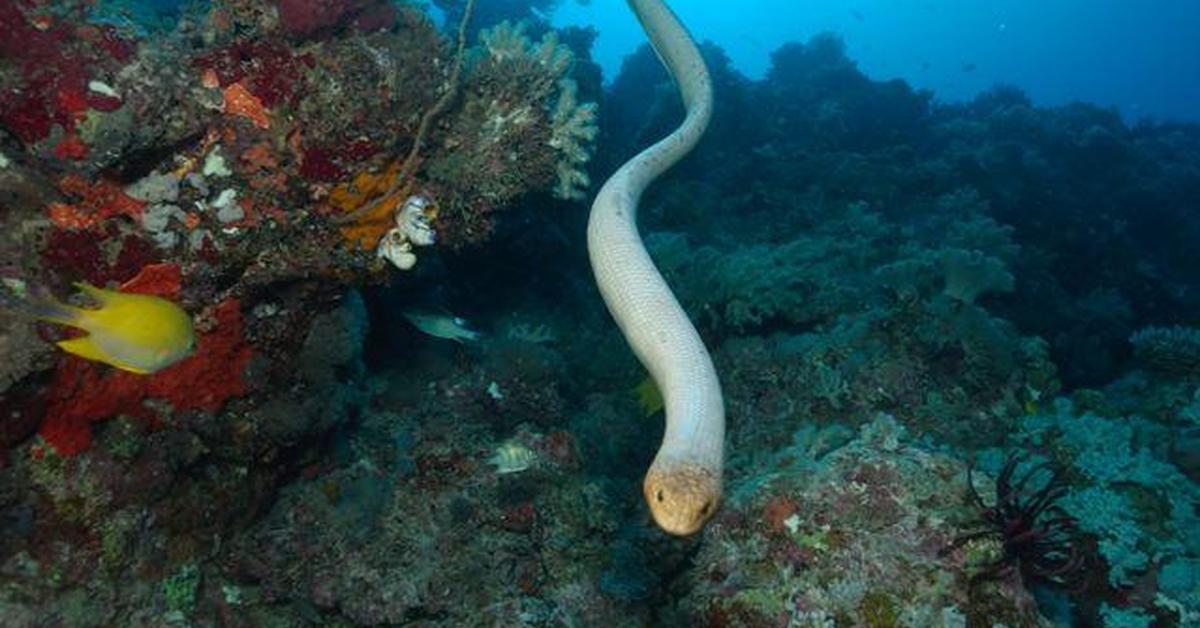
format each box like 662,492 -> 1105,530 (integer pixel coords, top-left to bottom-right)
31,283 -> 196,375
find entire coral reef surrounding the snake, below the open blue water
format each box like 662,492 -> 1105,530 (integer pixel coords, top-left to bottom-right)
0,0 -> 1200,628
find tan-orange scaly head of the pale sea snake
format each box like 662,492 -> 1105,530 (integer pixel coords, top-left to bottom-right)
642,462 -> 721,537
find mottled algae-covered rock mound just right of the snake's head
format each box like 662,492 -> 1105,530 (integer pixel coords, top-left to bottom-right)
679,415 -> 1048,627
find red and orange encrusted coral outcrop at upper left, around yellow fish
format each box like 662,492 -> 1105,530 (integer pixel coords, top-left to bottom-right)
0,2 -> 592,453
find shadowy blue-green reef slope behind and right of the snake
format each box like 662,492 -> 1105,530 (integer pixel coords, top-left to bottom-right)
592,27 -> 1200,626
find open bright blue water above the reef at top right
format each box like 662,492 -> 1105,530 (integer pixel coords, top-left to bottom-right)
554,0 -> 1200,121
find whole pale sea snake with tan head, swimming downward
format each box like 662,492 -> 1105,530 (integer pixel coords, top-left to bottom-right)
588,0 -> 725,534
